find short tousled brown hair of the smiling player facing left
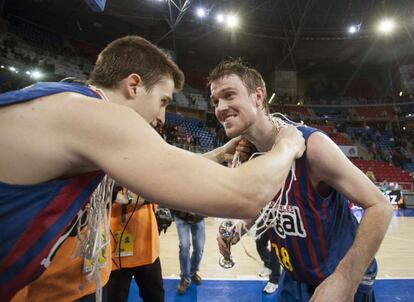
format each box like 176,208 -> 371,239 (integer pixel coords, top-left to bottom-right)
207,58 -> 268,112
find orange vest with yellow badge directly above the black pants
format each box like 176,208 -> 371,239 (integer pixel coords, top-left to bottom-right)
111,204 -> 160,270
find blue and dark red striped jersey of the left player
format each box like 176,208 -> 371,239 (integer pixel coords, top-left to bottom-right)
0,82 -> 104,301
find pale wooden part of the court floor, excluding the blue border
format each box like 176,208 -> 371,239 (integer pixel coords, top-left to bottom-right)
160,217 -> 414,279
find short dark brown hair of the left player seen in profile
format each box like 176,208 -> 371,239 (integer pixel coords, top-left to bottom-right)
89,36 -> 184,90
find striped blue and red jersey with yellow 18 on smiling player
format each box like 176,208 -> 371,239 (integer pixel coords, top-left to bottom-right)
270,126 -> 377,291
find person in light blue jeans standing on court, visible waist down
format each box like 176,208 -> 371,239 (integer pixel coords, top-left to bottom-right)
172,210 -> 206,294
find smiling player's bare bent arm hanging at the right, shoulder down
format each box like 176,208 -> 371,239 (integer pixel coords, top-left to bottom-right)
306,133 -> 392,301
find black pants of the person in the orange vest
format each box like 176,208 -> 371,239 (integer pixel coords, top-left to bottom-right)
108,258 -> 164,302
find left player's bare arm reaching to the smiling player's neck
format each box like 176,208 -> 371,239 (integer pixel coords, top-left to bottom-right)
64,95 -> 304,218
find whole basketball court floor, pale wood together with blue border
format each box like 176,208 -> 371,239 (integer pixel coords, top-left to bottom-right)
129,210 -> 414,302
